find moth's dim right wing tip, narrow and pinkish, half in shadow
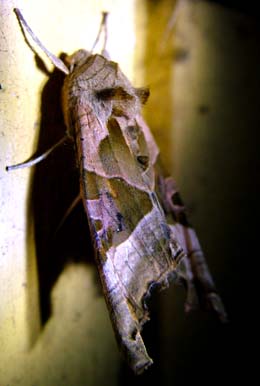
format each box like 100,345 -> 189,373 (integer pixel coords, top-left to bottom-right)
159,177 -> 227,322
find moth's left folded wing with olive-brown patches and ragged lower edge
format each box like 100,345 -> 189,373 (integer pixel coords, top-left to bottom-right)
75,105 -> 185,373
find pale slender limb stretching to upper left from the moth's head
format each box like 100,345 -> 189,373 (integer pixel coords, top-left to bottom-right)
14,8 -> 69,75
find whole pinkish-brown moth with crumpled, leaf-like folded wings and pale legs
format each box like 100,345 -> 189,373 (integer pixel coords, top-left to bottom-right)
7,9 -> 226,374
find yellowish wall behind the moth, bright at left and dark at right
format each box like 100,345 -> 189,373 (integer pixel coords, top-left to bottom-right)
0,0 -> 260,386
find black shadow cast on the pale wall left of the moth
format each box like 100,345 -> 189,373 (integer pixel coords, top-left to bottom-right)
28,58 -> 97,332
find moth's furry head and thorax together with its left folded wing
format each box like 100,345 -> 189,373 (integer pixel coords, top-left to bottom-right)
63,49 -> 187,373
